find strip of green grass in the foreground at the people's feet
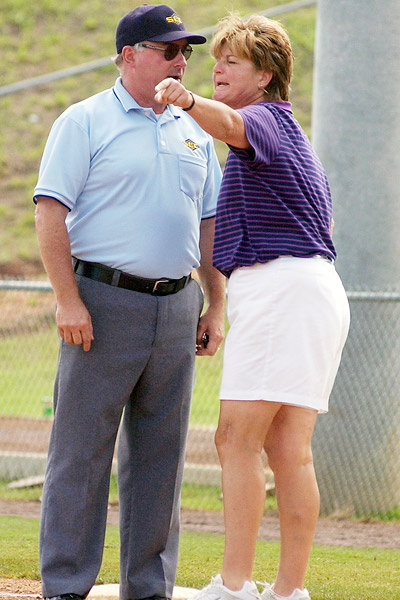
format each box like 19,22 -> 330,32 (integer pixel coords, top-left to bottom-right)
0,510 -> 400,600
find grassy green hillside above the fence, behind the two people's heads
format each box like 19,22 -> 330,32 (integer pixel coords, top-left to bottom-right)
0,0 -> 316,277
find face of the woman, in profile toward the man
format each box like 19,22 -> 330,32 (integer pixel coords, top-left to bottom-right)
213,44 -> 272,109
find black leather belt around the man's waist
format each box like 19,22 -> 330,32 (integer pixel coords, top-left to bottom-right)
72,257 -> 191,296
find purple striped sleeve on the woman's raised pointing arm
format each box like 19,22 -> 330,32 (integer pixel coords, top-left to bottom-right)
229,104 -> 281,167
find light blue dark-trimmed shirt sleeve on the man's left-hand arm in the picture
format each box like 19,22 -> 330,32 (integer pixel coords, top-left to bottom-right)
34,108 -> 90,210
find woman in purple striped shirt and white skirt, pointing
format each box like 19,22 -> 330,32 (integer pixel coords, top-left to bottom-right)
155,10 -> 349,600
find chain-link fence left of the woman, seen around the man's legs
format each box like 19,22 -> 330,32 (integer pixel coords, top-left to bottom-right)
0,280 -> 231,509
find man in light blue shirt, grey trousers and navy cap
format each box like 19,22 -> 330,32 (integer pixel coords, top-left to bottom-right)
34,4 -> 225,600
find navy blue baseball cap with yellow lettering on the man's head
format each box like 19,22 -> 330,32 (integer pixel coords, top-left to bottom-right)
115,4 -> 207,54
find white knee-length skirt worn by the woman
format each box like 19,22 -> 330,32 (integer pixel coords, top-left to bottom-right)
220,256 -> 350,413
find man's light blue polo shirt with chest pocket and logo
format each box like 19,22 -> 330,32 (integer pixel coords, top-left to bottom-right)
35,78 -> 221,278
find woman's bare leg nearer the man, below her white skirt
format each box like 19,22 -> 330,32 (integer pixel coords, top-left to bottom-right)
215,400 -> 281,590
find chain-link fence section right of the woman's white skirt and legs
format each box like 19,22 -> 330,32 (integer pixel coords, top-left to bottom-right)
313,291 -> 400,516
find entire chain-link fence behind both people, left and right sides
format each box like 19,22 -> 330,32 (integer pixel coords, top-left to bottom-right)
0,280 -> 400,516
